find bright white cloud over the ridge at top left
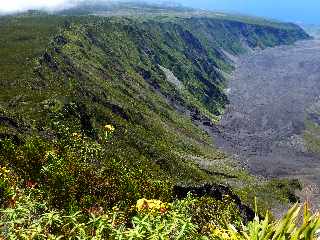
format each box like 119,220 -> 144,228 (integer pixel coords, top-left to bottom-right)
0,0 -> 80,13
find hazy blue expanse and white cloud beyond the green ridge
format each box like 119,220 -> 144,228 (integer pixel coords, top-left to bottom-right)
0,0 -> 320,24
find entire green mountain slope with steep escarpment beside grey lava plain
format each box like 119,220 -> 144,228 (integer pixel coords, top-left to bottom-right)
0,7 -> 309,238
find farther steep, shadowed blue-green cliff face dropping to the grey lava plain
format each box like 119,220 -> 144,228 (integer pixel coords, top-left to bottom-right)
31,17 -> 308,120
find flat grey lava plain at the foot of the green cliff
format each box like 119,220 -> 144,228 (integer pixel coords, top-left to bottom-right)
212,40 -> 320,206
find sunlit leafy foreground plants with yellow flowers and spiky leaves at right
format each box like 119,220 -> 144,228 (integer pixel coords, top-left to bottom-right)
0,177 -> 320,240
